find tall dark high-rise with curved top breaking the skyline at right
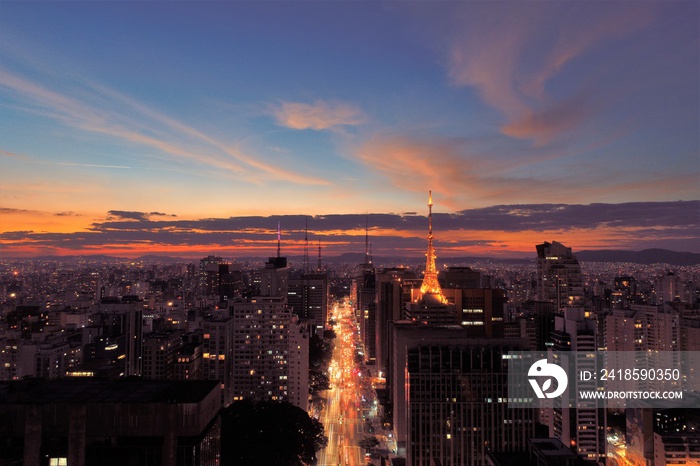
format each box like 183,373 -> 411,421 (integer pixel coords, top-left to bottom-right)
536,241 -> 583,313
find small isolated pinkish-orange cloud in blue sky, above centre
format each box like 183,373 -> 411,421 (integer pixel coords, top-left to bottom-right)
272,100 -> 367,131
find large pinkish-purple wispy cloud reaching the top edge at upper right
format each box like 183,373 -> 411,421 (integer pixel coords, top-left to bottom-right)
447,2 -> 653,144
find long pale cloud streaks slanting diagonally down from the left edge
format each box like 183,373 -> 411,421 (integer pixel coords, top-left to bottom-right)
0,70 -> 327,185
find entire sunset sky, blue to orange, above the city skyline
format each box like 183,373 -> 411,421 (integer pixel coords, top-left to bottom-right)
0,0 -> 700,257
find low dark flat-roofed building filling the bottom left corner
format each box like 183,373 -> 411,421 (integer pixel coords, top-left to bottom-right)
0,378 -> 221,466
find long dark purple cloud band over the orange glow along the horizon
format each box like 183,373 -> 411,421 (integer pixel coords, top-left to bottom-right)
0,201 -> 700,257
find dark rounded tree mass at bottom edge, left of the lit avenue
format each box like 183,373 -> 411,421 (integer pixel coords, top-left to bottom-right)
221,400 -> 328,466
